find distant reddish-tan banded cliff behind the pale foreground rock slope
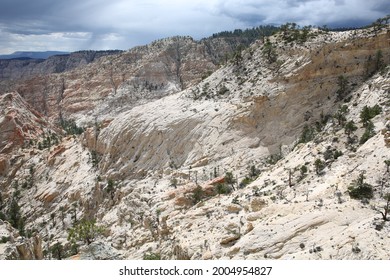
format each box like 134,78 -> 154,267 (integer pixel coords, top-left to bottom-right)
0,37 -> 254,122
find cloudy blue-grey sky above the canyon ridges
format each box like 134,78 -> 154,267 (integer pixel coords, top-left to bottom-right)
0,0 -> 390,54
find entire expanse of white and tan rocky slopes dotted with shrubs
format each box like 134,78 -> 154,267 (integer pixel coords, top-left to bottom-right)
0,25 -> 390,259
